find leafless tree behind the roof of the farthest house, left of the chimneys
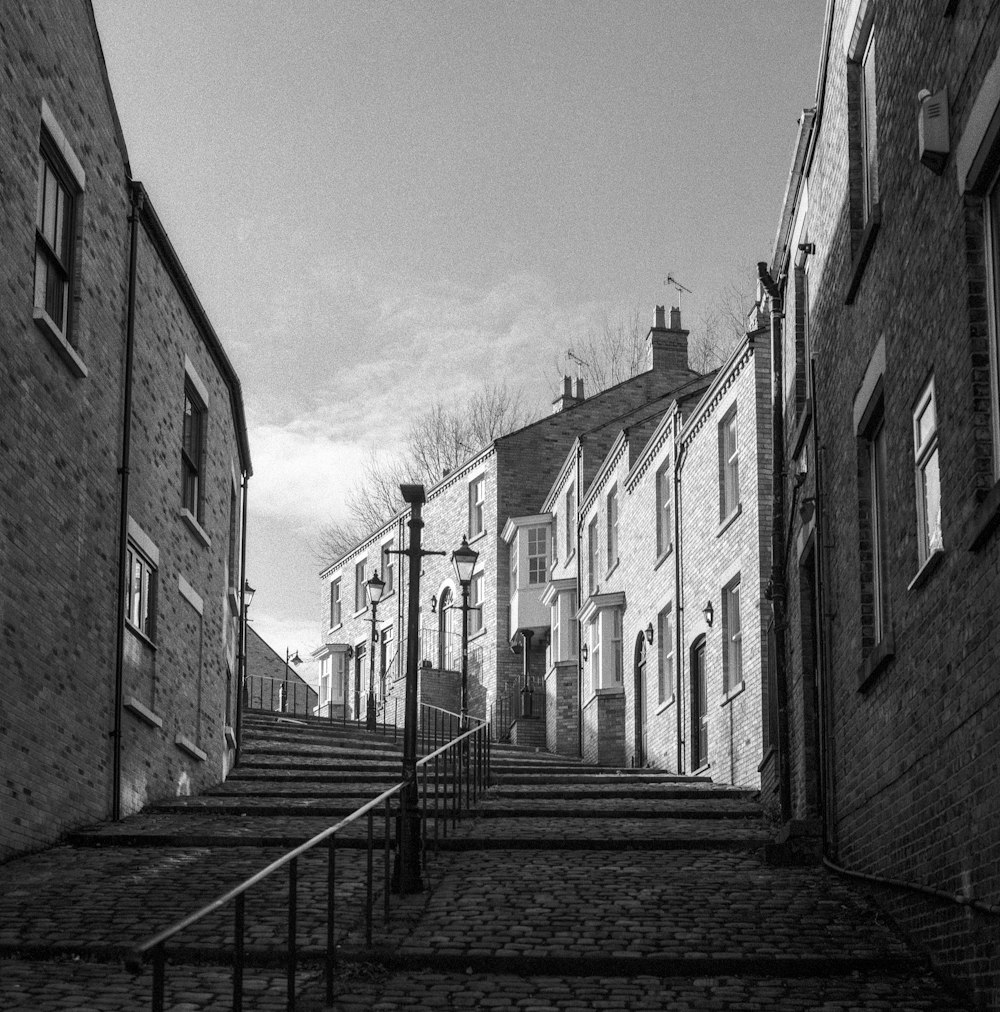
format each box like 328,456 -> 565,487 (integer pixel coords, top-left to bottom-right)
315,383 -> 530,566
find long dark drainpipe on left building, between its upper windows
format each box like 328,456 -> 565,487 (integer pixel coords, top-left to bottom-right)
111,182 -> 146,822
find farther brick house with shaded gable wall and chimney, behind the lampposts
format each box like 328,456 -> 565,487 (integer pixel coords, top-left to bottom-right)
313,303 -> 701,740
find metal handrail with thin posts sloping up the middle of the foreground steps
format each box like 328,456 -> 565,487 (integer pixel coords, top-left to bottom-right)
127,714 -> 490,1012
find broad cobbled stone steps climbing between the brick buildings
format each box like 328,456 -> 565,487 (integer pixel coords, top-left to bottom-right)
0,715 -> 967,1012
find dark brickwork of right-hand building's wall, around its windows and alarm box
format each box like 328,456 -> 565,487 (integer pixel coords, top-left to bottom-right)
775,0 -> 1000,1007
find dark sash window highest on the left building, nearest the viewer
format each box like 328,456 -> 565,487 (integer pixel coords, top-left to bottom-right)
34,132 -> 79,343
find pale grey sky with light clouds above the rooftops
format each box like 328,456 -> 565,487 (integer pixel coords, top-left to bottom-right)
93,0 -> 825,676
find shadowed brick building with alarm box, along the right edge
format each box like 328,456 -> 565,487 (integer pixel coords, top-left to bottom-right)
763,0 -> 1000,1008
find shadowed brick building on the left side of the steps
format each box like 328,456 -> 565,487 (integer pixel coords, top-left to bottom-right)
0,2 -> 251,858
